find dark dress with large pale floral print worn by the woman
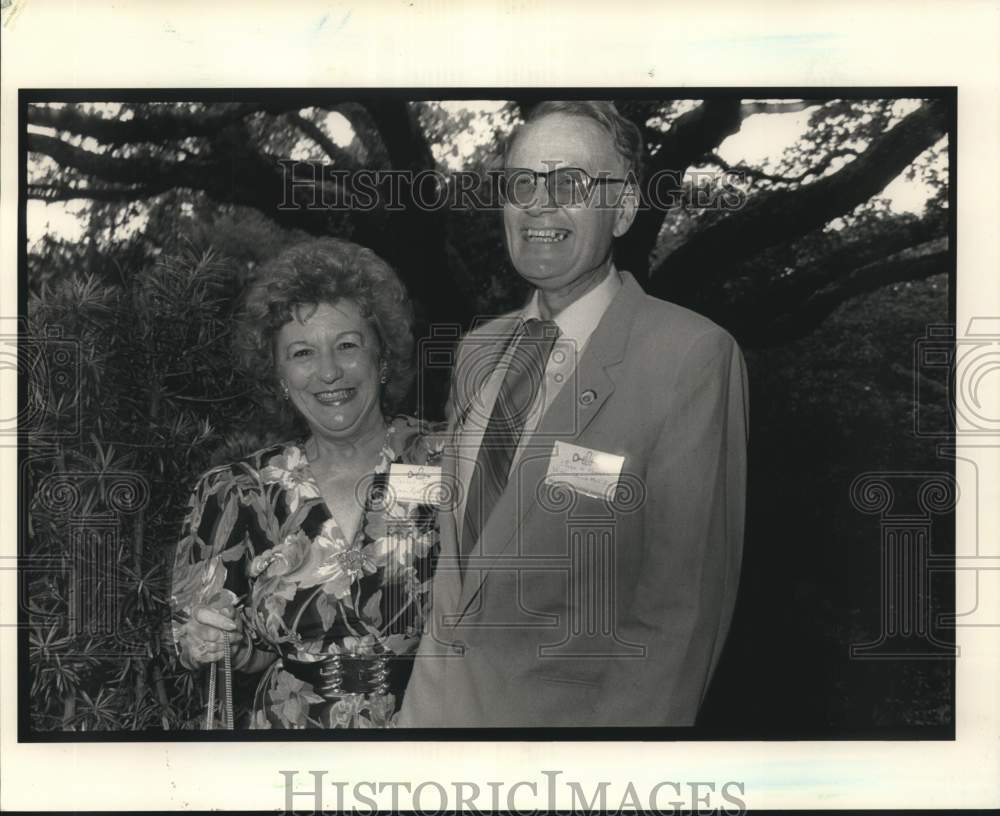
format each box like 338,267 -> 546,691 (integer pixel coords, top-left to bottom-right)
171,417 -> 441,728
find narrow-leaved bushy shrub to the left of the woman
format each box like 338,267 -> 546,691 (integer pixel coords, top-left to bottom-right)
26,247 -> 274,731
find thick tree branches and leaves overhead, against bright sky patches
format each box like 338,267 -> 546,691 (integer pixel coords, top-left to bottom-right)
27,94 -> 949,345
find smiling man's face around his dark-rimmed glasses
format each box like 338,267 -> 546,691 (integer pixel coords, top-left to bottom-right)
503,114 -> 635,292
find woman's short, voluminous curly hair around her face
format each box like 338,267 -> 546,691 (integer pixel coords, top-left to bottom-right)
236,238 -> 414,416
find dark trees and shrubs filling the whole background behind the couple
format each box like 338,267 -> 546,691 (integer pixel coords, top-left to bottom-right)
22,94 -> 953,737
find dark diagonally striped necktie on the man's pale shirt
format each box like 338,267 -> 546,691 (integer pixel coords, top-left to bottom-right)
462,318 -> 559,555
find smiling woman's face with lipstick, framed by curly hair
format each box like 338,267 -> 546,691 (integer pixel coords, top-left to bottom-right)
275,300 -> 383,440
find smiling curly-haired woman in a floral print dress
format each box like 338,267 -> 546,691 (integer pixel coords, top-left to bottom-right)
171,239 -> 440,728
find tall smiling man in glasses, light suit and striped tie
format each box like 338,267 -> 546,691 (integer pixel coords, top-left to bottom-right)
398,102 -> 746,727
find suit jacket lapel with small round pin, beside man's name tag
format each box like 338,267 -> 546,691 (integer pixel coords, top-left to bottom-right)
459,272 -> 645,612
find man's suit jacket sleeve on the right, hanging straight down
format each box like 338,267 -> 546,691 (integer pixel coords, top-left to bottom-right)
597,330 -> 747,725
